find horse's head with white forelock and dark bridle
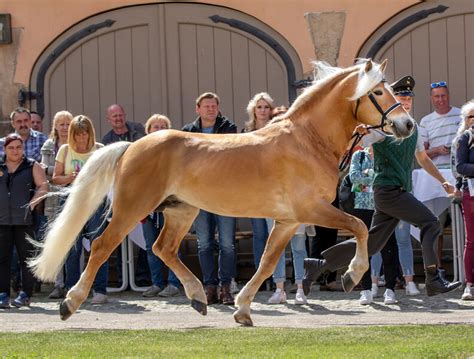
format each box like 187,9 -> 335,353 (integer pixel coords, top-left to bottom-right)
351,59 -> 415,138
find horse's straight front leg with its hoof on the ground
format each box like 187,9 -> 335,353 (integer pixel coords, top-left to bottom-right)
234,221 -> 299,326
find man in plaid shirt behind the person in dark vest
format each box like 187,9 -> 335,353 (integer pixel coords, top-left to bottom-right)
0,107 -> 48,162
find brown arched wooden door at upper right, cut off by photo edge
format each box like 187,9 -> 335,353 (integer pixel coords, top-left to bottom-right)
359,0 -> 474,120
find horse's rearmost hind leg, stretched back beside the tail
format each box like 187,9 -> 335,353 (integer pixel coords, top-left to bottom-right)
59,212 -> 140,320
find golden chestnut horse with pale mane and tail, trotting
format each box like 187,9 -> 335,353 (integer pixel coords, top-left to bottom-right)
30,60 -> 414,325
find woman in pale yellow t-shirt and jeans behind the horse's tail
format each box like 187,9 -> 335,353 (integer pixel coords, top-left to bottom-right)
53,115 -> 108,304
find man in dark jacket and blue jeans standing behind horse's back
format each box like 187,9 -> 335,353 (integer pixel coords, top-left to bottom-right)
183,92 -> 237,305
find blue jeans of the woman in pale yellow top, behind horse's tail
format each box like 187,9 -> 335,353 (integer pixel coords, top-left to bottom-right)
65,204 -> 109,294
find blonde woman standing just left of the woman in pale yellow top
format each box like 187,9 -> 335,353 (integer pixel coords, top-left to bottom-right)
41,111 -> 73,299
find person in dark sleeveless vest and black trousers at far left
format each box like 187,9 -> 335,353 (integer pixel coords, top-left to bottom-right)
0,134 -> 48,308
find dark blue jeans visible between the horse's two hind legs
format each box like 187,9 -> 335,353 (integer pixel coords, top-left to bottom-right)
142,213 -> 180,288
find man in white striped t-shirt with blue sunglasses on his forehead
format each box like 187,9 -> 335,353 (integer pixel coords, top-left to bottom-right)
420,81 -> 461,273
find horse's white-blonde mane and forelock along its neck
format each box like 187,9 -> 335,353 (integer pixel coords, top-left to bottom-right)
278,59 -> 383,122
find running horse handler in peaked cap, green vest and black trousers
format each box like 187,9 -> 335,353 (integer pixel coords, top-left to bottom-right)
303,76 -> 461,296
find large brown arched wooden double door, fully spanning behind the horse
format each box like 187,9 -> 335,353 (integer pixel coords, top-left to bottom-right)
30,3 -> 302,137
